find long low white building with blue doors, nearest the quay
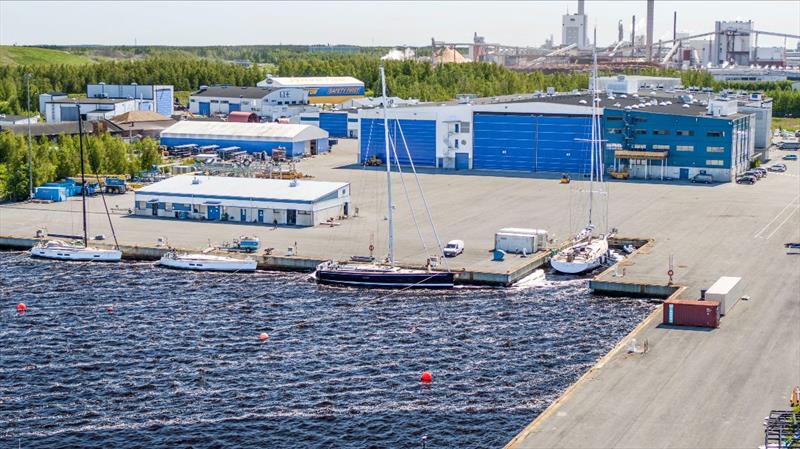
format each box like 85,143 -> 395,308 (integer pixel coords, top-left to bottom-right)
134,175 -> 350,226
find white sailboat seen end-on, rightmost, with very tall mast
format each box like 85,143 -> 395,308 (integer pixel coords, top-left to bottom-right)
550,38 -> 609,274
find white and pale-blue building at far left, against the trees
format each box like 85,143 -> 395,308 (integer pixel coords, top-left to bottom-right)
86,83 -> 175,117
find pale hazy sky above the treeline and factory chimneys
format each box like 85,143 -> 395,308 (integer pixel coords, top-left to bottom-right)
0,0 -> 800,48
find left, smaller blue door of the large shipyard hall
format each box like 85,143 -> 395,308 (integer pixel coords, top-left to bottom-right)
359,118 -> 436,167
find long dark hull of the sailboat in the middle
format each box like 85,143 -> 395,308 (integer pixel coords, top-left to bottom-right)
315,270 -> 454,288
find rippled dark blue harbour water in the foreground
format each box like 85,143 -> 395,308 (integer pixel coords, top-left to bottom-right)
0,253 -> 654,448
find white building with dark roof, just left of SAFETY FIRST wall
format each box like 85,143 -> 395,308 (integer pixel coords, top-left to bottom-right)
189,86 -> 308,121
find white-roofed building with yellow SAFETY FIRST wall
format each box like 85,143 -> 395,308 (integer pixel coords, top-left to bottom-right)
257,75 -> 364,104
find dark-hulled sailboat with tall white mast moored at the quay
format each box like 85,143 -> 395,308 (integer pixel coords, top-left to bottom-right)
314,67 -> 455,288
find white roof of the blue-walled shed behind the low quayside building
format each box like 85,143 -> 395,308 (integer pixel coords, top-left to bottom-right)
161,120 -> 328,142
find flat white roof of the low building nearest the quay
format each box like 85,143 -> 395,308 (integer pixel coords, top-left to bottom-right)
136,175 -> 349,202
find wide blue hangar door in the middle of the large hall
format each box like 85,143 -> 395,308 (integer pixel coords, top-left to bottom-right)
472,113 -> 591,173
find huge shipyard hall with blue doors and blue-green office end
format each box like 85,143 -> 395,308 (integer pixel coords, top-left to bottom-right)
358,84 -> 760,182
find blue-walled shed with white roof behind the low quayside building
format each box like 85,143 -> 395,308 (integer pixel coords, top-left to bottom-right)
161,120 -> 330,158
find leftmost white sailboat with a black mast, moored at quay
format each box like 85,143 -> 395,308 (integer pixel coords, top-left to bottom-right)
31,105 -> 122,262
